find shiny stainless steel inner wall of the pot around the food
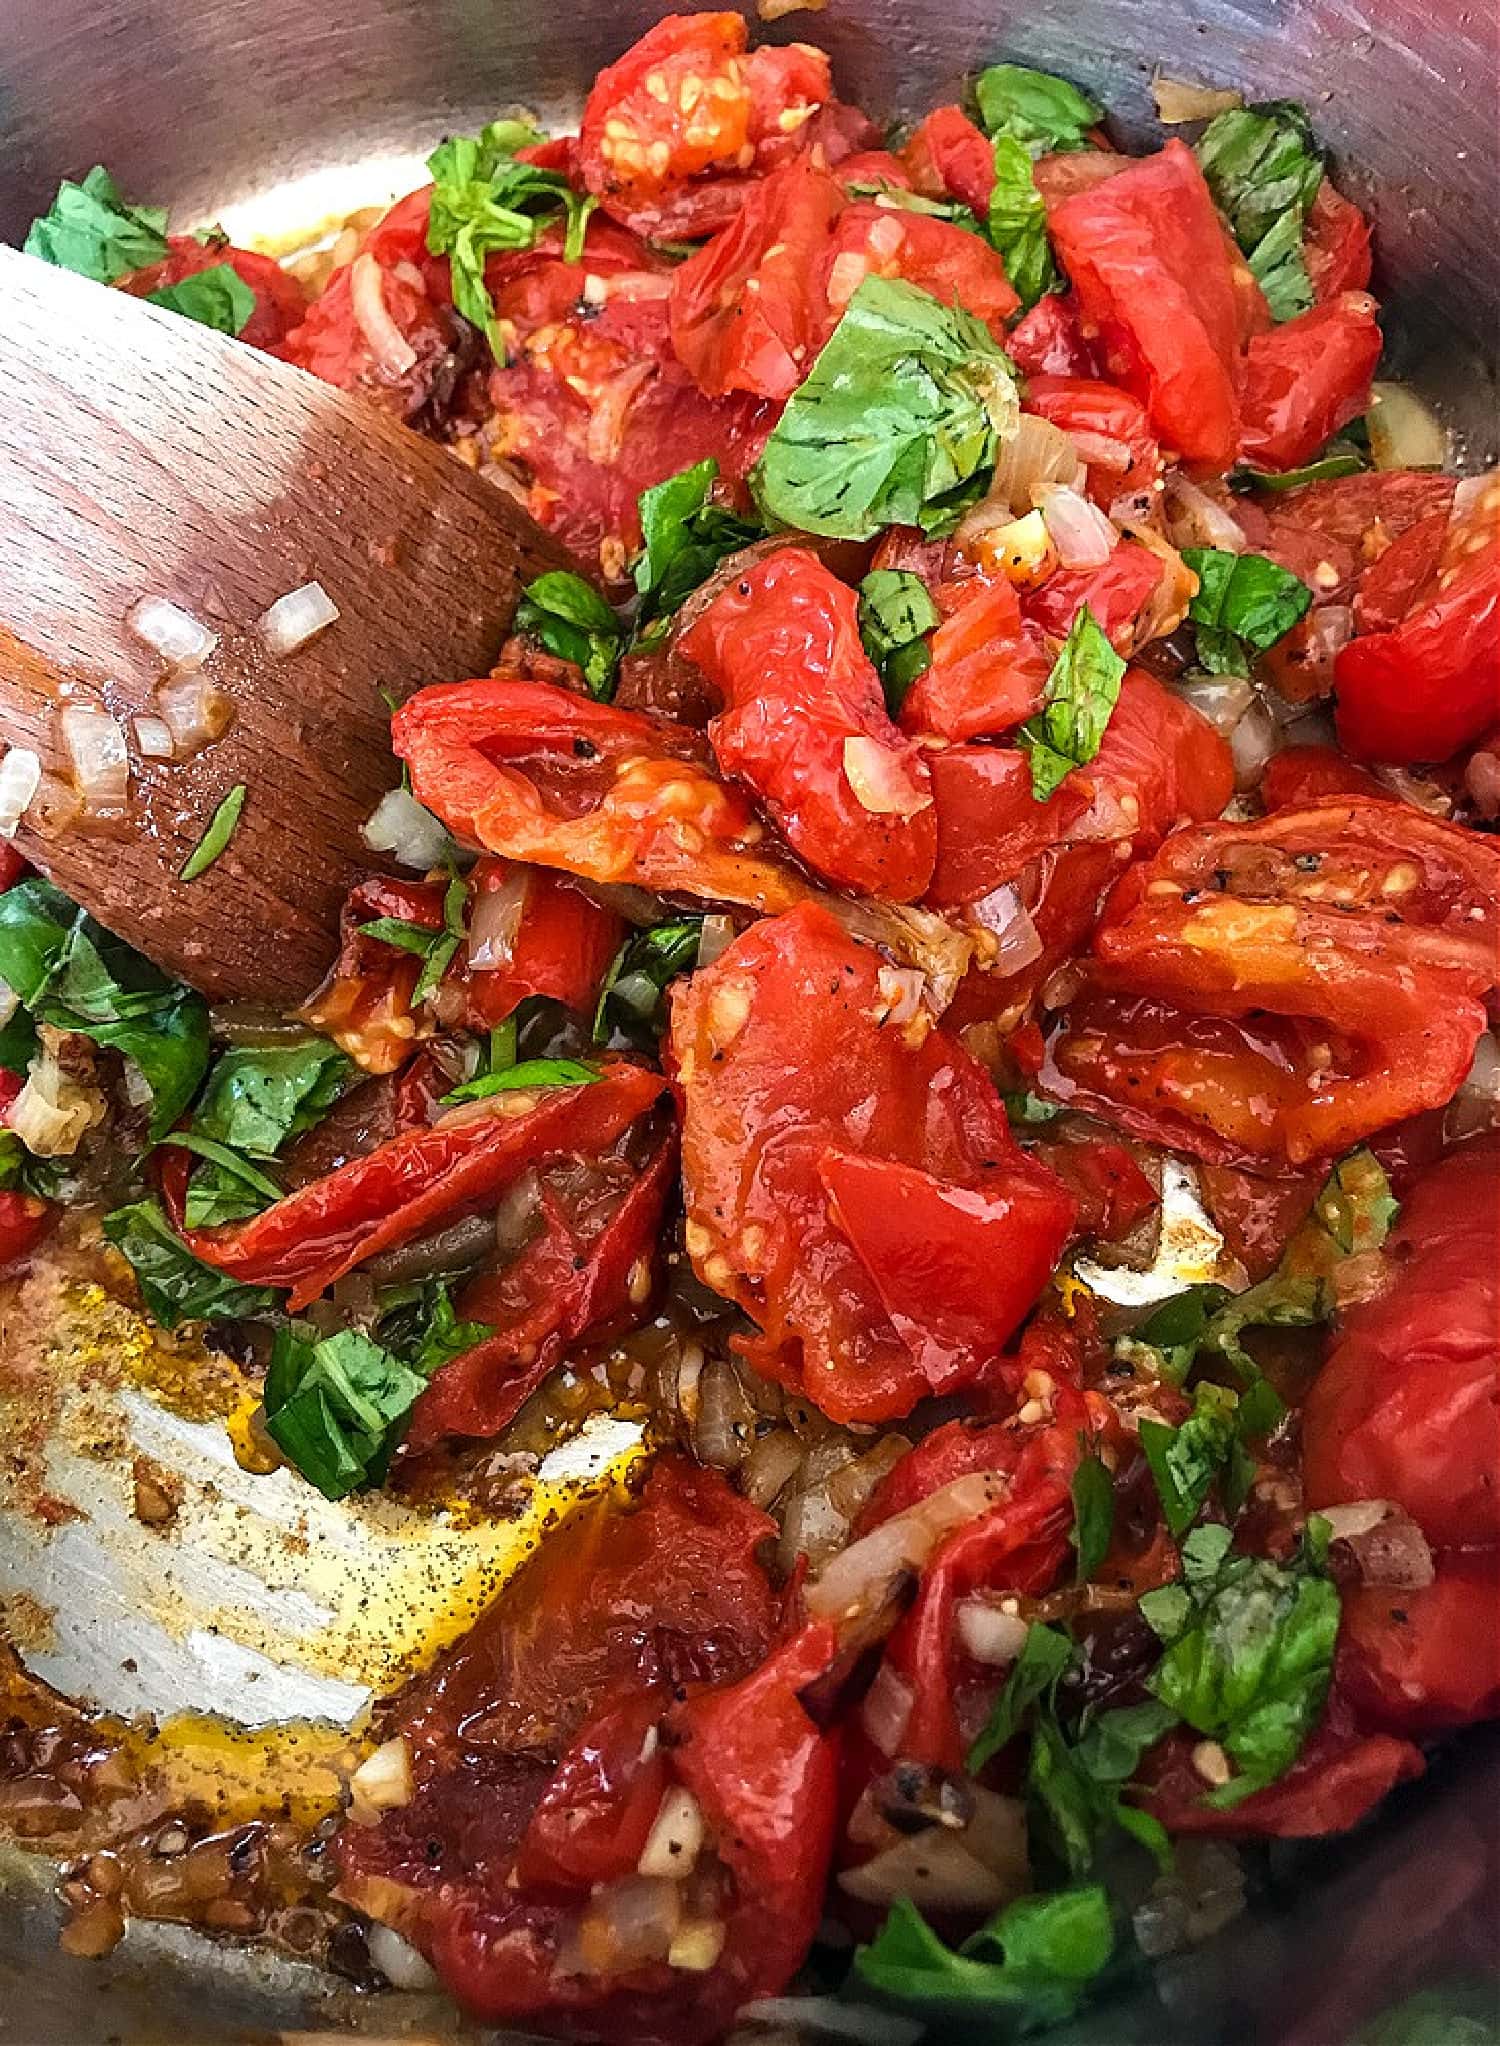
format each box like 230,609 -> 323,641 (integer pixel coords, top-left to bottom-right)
0,0 -> 1500,2046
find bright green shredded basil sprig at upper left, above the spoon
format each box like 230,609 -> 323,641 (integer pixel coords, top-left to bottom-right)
428,121 -> 598,362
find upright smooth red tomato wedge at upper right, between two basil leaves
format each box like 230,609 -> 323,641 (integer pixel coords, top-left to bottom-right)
1050,141 -> 1240,471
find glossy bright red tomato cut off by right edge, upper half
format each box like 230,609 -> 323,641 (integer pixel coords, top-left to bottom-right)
1334,479 -> 1500,761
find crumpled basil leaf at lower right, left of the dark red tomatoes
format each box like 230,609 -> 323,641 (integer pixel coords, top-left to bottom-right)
1140,1516 -> 1338,1811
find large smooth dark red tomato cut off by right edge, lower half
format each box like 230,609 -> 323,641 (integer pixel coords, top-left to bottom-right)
1304,1138 -> 1500,1549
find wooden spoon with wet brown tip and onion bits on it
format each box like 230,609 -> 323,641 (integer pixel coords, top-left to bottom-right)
0,250 -> 569,1007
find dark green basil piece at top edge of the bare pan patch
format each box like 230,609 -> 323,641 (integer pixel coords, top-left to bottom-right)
264,1322 -> 428,1500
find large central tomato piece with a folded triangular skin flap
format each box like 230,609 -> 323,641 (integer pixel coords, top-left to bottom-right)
671,904 -> 1072,1420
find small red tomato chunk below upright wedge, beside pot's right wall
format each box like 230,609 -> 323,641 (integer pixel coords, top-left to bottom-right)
1240,291 -> 1381,469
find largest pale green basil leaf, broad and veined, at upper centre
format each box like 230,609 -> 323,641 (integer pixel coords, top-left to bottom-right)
751,276 -> 1019,540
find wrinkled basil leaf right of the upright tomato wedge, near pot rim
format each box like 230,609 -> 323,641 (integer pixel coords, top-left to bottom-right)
1197,100 -> 1324,319
